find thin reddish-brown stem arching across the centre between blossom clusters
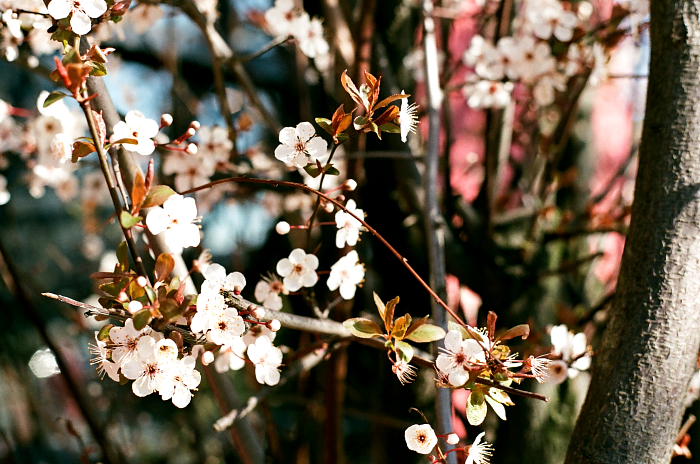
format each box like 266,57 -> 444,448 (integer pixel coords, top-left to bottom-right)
180,177 -> 467,327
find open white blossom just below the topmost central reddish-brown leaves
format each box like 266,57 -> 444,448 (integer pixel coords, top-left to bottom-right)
275,122 -> 328,168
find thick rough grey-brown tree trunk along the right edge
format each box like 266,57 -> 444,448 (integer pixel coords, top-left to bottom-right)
566,0 -> 700,464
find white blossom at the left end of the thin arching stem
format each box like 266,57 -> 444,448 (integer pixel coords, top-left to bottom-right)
146,194 -> 200,253
